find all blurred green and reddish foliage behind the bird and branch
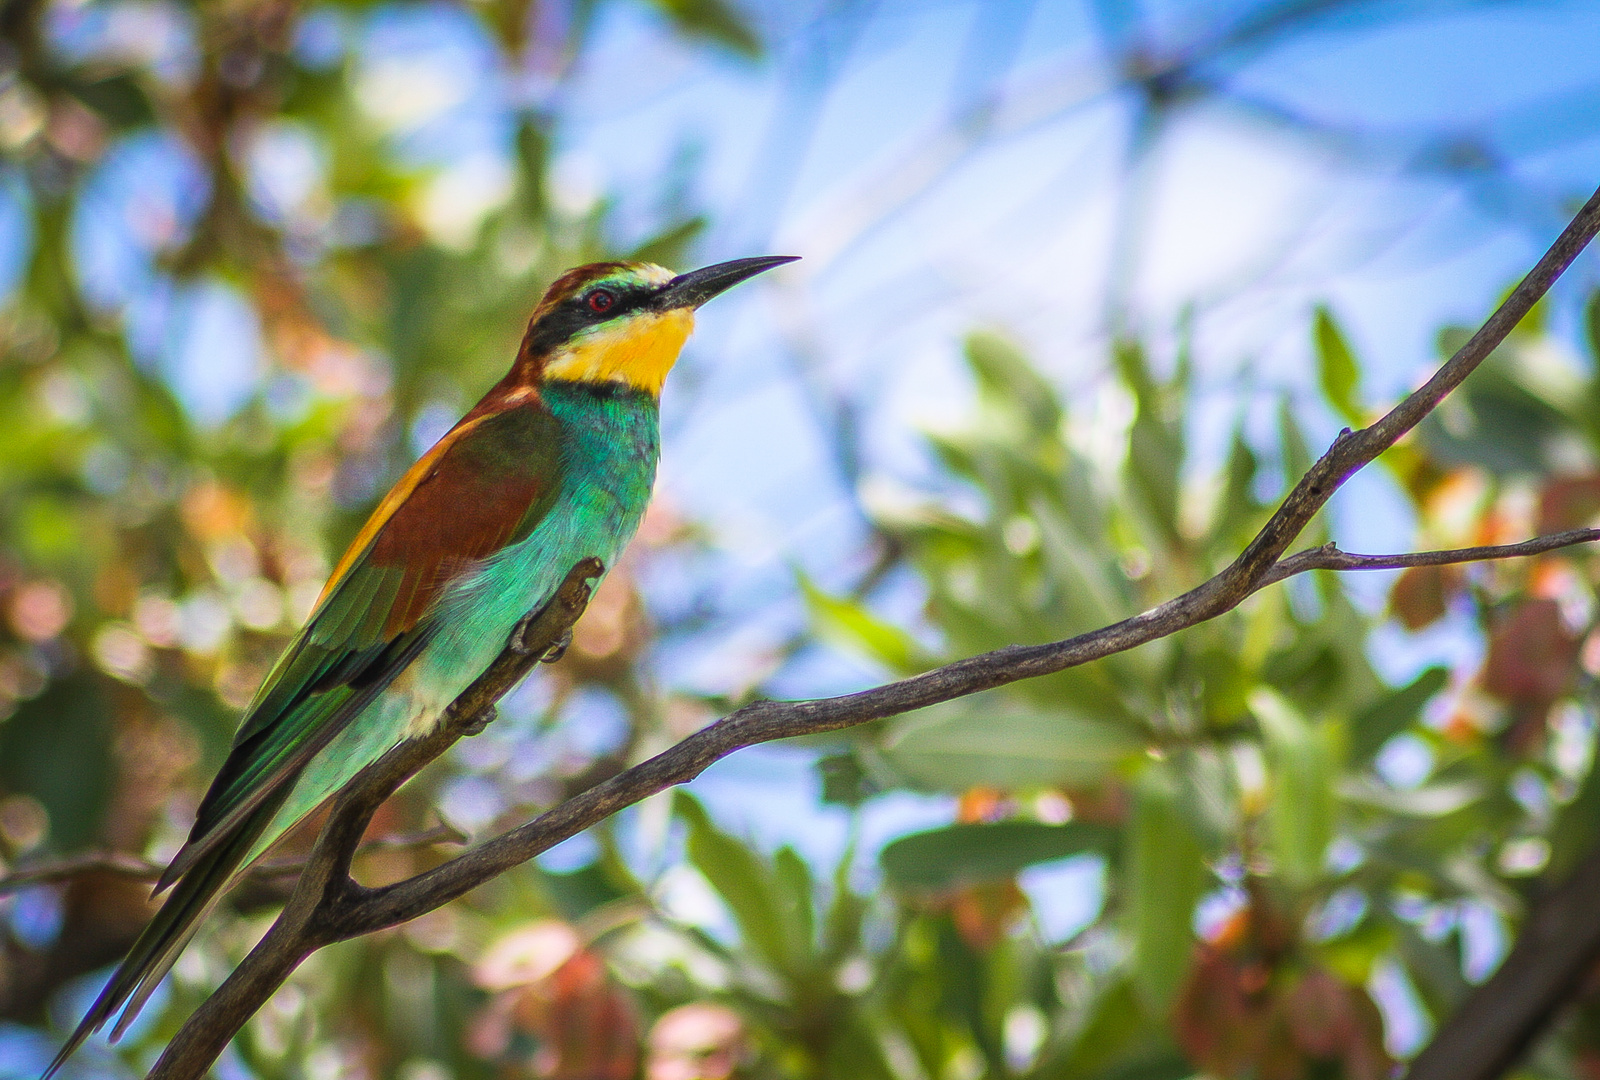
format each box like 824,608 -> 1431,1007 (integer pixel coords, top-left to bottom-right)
0,0 -> 1600,1080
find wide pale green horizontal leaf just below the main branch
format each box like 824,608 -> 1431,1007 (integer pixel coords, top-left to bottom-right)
882,693 -> 1146,790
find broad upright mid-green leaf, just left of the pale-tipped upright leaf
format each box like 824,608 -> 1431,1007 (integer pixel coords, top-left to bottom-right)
1126,763 -> 1206,1014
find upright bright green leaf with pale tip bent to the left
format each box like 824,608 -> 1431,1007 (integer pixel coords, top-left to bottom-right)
1250,686 -> 1336,886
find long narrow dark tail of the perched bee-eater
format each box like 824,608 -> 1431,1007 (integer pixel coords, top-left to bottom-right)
45,782 -> 294,1080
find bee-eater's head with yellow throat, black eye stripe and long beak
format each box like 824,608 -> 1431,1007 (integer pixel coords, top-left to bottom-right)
518,254 -> 794,395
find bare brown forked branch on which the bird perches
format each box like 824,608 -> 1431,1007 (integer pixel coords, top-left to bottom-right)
140,190 -> 1600,1080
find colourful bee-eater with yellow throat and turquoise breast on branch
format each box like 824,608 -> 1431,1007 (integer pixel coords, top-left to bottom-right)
46,256 -> 792,1077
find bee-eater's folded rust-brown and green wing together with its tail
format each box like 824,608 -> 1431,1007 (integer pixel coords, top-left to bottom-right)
46,398 -> 563,1075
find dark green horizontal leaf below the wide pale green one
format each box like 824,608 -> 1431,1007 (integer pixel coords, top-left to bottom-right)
878,821 -> 1117,893
